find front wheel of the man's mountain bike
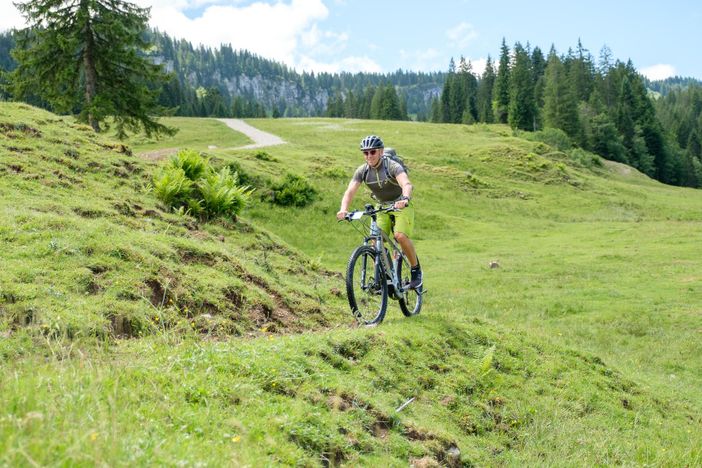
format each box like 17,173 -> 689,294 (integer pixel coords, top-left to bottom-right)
346,245 -> 388,325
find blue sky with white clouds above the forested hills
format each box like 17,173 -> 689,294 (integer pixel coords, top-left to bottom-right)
0,0 -> 702,79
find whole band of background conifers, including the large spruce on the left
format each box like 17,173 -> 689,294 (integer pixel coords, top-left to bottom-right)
0,0 -> 702,187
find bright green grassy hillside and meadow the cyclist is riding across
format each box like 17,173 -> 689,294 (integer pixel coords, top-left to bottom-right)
0,103 -> 702,466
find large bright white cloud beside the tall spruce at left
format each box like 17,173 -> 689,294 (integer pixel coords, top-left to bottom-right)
0,0 -> 374,72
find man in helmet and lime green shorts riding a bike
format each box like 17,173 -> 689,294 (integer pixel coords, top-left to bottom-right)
336,135 -> 422,289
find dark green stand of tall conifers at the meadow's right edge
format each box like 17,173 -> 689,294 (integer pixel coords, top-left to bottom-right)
431,40 -> 702,187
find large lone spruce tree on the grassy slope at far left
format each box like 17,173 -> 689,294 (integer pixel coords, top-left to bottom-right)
10,0 -> 173,137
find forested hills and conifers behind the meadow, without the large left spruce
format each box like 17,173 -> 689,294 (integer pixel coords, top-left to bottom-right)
0,27 -> 702,187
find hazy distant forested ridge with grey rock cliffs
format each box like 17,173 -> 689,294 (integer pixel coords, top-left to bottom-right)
150,31 -> 444,117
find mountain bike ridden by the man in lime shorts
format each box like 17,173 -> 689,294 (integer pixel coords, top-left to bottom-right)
344,204 -> 424,326
